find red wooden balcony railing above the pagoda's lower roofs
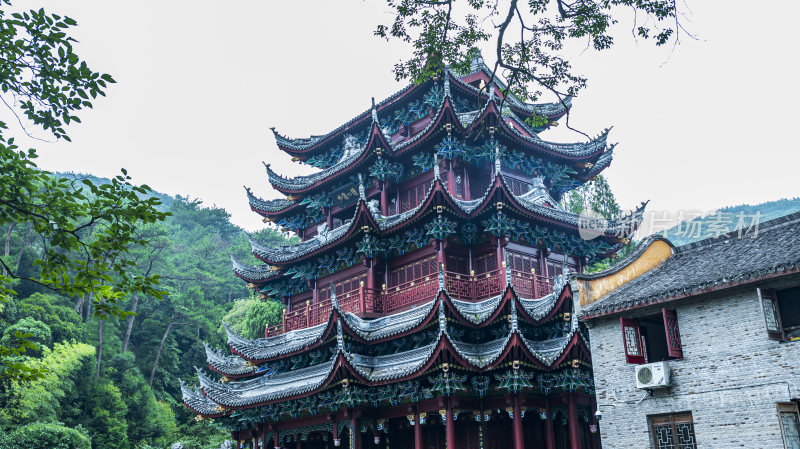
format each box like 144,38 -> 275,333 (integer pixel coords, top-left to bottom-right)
265,270 -> 553,337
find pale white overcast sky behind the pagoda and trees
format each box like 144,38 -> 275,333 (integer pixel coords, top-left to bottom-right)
7,0 -> 800,230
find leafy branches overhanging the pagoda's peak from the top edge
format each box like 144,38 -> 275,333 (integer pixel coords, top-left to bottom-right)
375,0 -> 686,130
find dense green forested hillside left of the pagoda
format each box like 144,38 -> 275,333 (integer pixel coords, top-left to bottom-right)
0,174 -> 284,449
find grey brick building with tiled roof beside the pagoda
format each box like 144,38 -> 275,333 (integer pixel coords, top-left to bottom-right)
573,214 -> 800,449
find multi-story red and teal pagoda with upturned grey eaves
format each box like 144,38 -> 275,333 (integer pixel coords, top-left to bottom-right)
183,54 -> 641,449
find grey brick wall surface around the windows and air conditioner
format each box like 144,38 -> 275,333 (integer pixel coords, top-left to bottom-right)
587,288 -> 800,449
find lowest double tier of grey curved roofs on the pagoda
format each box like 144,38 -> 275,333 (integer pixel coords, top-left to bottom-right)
184,268 -> 588,417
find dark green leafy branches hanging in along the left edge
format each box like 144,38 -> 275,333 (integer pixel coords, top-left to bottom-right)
0,0 -> 165,379
